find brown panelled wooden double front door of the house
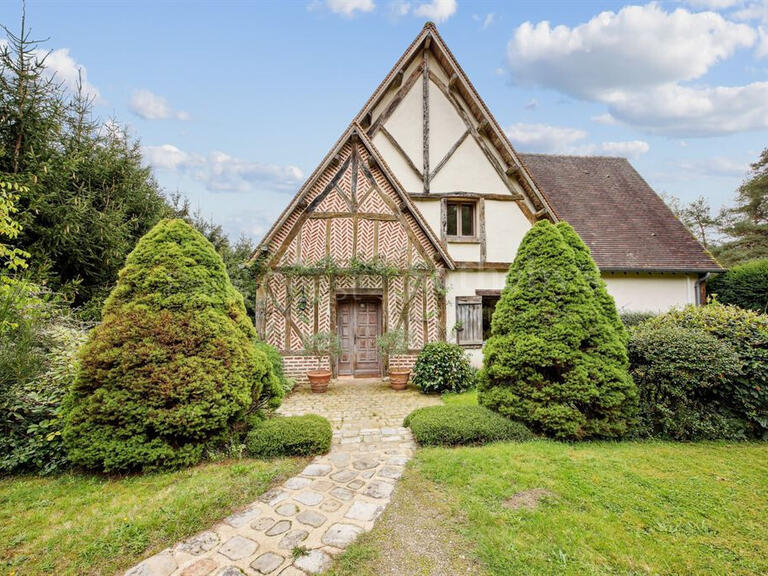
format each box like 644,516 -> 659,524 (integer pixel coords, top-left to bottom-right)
337,297 -> 381,376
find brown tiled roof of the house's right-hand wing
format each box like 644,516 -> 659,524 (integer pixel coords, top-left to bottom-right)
520,154 -> 722,272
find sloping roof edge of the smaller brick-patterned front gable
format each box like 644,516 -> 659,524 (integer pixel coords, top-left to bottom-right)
251,122 -> 456,270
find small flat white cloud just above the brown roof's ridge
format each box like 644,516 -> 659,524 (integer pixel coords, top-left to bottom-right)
506,123 -> 650,157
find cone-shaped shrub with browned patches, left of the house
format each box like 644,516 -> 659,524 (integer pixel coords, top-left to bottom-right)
64,220 -> 274,472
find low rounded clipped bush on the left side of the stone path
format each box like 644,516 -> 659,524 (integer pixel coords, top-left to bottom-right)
245,414 -> 333,458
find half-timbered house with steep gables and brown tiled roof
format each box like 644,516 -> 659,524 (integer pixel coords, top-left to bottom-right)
254,23 -> 720,378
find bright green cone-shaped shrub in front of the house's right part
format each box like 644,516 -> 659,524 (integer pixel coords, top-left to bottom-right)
478,221 -> 637,439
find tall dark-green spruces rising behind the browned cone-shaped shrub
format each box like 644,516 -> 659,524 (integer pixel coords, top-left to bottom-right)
0,12 -> 168,305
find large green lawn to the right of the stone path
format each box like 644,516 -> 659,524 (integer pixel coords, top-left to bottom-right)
328,440 -> 768,576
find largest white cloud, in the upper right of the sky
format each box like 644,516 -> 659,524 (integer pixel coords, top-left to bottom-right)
507,3 -> 768,136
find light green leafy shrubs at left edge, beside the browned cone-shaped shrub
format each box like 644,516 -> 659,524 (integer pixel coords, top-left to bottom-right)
0,278 -> 86,473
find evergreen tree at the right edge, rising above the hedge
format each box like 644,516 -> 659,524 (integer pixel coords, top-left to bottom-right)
716,148 -> 768,265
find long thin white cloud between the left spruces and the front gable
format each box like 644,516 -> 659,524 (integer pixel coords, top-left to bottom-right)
143,144 -> 304,192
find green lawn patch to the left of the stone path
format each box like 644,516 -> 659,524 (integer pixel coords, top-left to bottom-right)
0,459 -> 305,576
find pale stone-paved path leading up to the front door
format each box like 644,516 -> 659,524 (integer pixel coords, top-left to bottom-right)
125,380 -> 440,576
